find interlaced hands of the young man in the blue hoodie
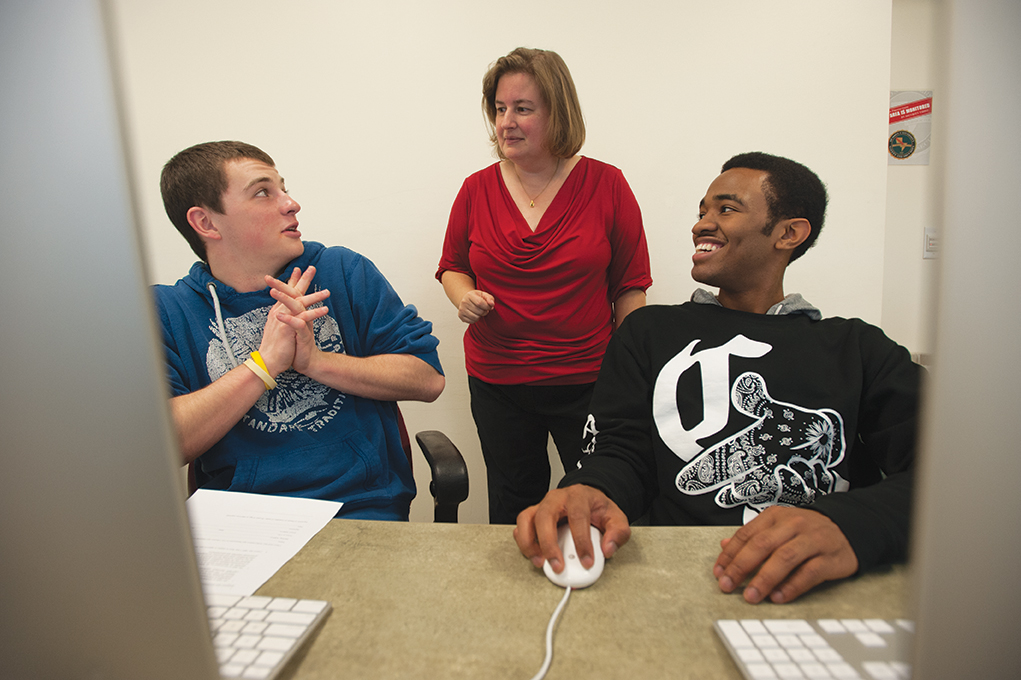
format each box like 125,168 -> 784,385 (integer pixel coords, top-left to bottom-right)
259,265 -> 330,376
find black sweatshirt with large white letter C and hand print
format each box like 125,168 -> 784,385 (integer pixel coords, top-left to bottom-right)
561,302 -> 921,570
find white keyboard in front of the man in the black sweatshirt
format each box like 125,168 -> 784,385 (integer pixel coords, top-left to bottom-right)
716,619 -> 915,680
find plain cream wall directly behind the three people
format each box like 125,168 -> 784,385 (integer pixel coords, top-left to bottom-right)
112,0 -> 896,522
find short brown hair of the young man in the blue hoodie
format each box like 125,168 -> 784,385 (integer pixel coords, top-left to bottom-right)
159,142 -> 277,261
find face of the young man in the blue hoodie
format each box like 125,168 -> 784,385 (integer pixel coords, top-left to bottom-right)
207,158 -> 304,277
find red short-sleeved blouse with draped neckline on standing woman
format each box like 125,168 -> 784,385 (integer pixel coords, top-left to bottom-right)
436,157 -> 652,385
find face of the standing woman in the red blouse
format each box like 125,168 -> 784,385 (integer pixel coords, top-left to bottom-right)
494,74 -> 551,164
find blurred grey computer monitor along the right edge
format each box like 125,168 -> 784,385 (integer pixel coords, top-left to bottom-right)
904,0 -> 1021,679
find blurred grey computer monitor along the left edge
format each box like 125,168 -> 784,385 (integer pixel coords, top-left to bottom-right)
0,0 -> 218,680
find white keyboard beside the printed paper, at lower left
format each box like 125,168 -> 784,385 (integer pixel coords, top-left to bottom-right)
205,594 -> 331,680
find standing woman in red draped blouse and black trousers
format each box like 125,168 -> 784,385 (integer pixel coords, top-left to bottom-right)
436,48 -> 652,524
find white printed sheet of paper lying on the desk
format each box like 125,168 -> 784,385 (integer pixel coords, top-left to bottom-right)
186,489 -> 343,595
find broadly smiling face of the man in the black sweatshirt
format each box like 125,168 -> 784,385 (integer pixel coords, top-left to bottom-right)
691,167 -> 788,297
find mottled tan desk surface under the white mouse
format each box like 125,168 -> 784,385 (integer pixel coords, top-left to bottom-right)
258,520 -> 907,680
